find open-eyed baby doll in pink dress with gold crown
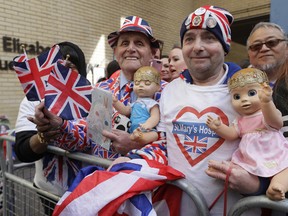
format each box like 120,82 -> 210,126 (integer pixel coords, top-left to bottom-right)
206,68 -> 288,200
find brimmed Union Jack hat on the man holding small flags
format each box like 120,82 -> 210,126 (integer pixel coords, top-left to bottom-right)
108,16 -> 159,48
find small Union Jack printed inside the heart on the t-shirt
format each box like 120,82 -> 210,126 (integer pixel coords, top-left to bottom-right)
184,135 -> 208,154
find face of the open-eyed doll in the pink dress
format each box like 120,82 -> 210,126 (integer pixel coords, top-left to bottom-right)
230,83 -> 261,116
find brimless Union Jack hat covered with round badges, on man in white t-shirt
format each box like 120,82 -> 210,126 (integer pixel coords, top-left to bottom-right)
180,5 -> 234,53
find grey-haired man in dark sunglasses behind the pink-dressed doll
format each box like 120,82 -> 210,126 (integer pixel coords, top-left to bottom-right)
247,22 -> 288,139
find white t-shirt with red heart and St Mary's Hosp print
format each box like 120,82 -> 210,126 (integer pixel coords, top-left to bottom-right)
157,78 -> 257,215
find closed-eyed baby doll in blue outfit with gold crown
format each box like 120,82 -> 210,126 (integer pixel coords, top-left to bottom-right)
113,66 -> 161,144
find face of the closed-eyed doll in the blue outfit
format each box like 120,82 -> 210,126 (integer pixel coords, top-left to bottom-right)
133,80 -> 160,98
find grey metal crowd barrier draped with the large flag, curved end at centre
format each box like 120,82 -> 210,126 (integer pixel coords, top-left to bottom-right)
0,132 -> 209,216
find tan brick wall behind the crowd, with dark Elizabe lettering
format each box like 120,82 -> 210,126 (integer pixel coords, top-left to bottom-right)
0,0 -> 270,127
